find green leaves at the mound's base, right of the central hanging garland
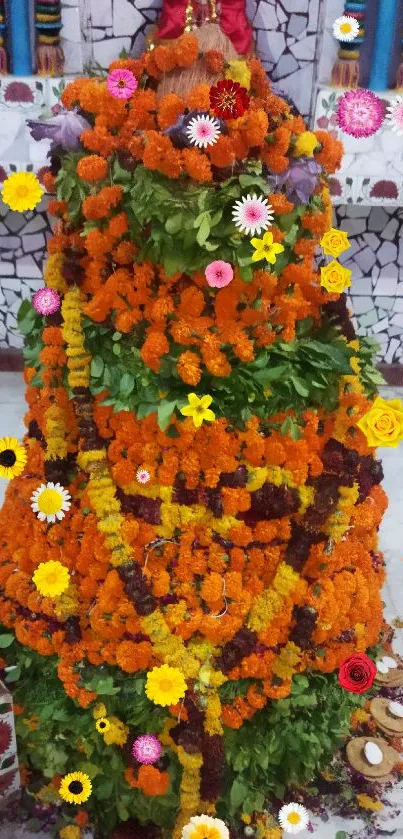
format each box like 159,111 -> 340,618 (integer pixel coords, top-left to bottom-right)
220,674 -> 364,816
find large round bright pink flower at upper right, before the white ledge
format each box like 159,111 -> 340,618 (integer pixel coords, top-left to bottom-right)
336,88 -> 385,139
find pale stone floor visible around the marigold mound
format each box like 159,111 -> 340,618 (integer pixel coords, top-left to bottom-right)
0,373 -> 403,839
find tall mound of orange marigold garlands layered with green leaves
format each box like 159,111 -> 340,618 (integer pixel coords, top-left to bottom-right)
0,35 -> 394,839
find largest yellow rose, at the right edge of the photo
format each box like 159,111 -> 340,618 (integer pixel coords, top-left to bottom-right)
357,396 -> 403,449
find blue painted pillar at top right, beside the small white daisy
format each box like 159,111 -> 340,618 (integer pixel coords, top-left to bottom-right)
368,0 -> 398,90
